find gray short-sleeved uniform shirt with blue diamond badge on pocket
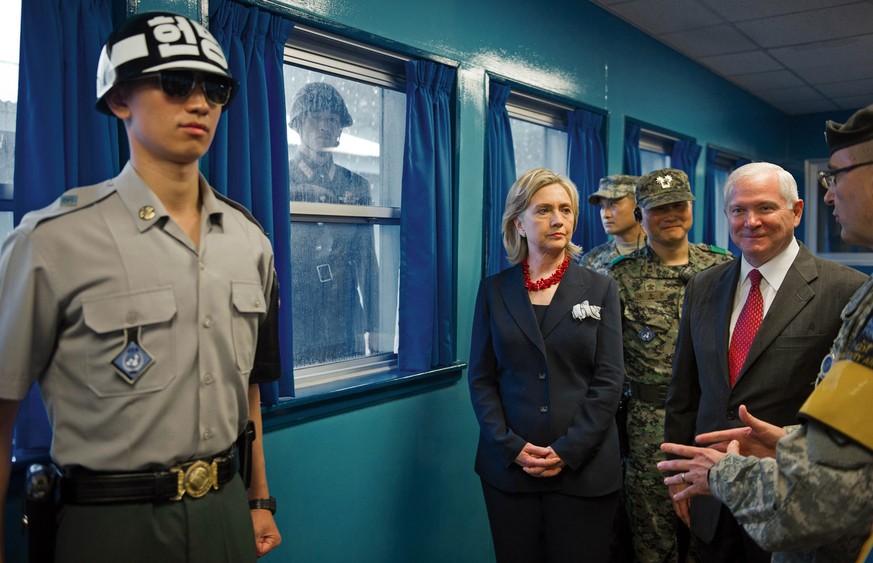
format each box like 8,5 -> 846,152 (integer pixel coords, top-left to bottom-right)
0,164 -> 274,471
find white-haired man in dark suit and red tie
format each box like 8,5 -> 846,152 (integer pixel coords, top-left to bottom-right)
665,162 -> 866,561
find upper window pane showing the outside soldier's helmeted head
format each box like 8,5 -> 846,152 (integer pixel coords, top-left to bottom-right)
285,65 -> 406,207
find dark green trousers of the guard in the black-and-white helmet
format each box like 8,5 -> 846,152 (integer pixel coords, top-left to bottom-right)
55,475 -> 257,563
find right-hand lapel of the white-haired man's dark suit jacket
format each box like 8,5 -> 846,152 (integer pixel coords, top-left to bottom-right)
739,245 -> 818,384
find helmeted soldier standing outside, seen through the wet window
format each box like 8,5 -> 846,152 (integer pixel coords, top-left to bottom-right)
290,82 -> 379,367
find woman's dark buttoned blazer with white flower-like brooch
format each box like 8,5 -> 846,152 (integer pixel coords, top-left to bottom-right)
468,263 -> 624,496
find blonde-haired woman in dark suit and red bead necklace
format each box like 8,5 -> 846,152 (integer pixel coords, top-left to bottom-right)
468,168 -> 624,563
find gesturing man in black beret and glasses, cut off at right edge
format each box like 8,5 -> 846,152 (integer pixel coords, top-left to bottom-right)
658,106 -> 873,562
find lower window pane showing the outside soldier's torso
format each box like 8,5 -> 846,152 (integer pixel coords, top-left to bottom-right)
291,221 -> 400,368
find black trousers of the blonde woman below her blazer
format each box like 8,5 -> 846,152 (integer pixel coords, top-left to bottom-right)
482,481 -> 618,563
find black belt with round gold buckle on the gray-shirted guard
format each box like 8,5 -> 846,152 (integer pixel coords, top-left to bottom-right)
61,447 -> 238,504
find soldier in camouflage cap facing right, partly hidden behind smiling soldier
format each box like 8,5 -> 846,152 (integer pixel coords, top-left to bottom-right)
579,174 -> 646,274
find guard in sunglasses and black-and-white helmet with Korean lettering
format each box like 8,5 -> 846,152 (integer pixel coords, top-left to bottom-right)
0,12 -> 280,563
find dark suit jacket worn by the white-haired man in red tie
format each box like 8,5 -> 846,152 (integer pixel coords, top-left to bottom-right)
664,245 -> 867,542
